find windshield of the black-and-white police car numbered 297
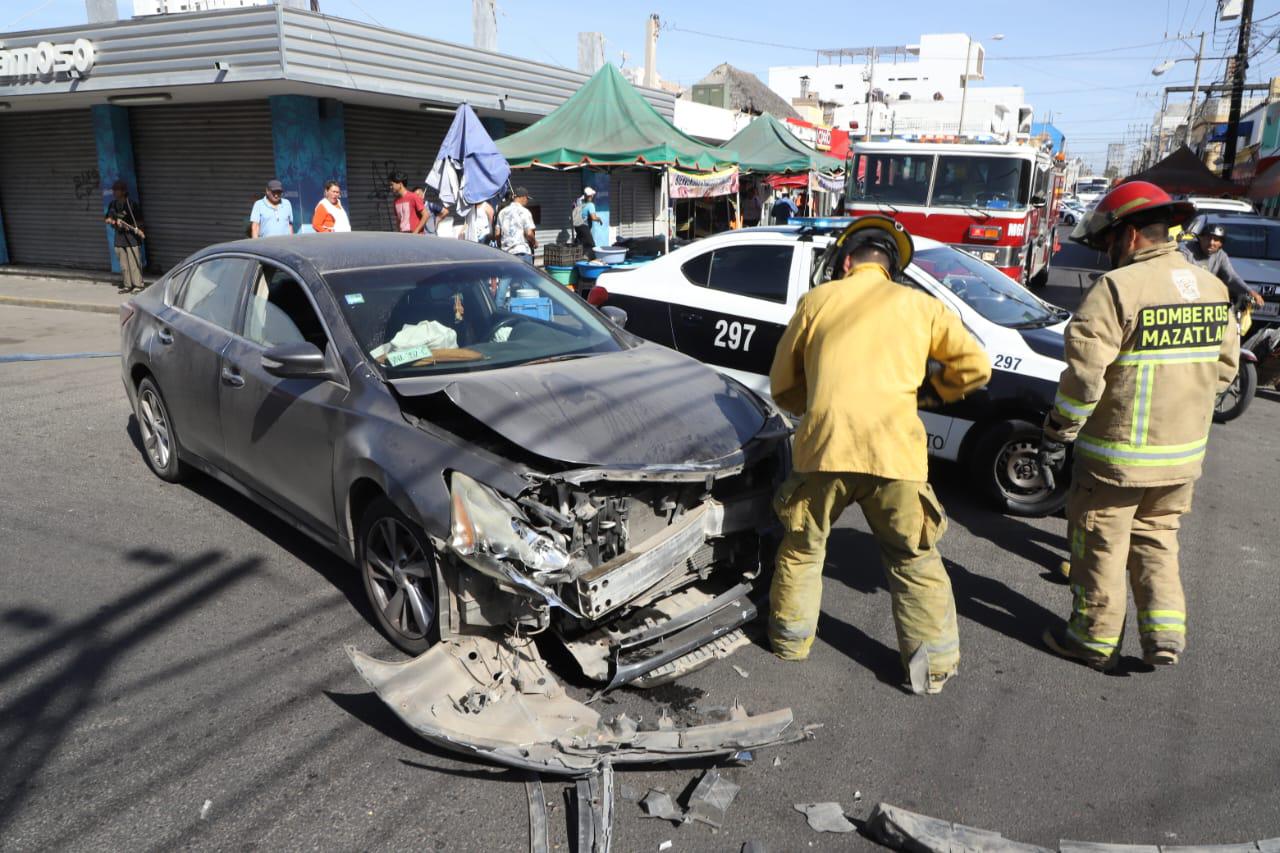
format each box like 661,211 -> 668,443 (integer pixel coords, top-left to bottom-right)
911,246 -> 1069,329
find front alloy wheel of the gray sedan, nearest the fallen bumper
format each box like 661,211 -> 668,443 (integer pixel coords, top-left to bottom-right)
360,501 -> 436,654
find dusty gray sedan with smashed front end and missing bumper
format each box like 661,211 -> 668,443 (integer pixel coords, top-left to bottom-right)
122,233 -> 790,702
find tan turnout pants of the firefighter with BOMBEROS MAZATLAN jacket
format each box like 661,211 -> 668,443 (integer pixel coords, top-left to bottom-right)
1066,465 -> 1194,662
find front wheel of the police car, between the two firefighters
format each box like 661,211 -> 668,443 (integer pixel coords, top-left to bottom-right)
970,420 -> 1070,516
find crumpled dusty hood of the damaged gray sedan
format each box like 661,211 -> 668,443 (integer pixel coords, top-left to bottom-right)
390,343 -> 765,466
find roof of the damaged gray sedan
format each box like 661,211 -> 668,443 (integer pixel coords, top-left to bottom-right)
192,231 -> 516,274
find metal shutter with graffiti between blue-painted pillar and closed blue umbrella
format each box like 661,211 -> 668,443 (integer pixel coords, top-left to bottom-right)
343,104 -> 453,231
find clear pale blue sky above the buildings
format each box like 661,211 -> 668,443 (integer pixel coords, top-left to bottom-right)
10,0 -> 1280,168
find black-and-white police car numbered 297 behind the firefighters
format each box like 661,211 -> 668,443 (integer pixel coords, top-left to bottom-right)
589,218 -> 1070,516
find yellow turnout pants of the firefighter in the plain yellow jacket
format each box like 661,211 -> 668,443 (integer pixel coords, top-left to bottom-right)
769,471 -> 960,692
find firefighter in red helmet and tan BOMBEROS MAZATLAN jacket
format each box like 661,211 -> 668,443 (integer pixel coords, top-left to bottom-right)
1041,181 -> 1240,670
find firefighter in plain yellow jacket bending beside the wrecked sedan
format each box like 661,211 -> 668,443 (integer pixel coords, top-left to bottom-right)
769,215 -> 991,693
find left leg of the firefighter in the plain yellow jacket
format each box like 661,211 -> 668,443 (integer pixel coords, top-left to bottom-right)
768,473 -> 849,661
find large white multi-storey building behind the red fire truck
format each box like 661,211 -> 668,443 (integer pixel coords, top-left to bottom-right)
769,33 -> 1032,138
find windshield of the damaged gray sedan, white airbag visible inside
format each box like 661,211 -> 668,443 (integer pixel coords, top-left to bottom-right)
325,260 -> 623,378
